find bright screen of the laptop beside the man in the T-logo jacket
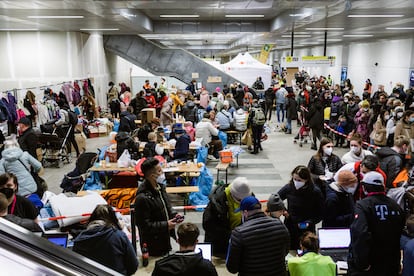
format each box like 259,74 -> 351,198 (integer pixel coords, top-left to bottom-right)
318,228 -> 351,249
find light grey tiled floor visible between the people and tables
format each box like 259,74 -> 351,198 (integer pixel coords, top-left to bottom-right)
44,123 -> 346,275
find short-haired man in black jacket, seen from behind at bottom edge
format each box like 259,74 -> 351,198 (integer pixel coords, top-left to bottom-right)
152,222 -> 217,276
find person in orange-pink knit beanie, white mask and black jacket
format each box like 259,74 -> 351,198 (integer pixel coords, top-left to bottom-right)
322,170 -> 358,228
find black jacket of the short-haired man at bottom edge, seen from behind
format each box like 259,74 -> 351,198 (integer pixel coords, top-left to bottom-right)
154,251 -> 204,275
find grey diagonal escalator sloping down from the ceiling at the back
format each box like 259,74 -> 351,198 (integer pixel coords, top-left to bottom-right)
104,35 -> 243,91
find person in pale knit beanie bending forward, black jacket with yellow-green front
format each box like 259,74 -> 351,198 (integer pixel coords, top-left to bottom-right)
203,177 -> 252,258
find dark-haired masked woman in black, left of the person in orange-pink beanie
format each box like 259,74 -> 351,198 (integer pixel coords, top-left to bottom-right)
278,165 -> 324,251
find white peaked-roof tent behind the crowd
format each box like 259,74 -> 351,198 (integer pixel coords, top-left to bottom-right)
222,53 -> 272,89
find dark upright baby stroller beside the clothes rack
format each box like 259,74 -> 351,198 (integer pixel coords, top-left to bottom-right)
38,123 -> 72,168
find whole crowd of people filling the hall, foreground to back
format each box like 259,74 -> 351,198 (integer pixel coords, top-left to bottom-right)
0,72 -> 414,275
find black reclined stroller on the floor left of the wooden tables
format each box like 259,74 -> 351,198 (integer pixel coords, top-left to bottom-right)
60,152 -> 98,193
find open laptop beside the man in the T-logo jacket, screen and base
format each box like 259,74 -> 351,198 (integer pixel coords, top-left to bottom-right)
318,228 -> 351,262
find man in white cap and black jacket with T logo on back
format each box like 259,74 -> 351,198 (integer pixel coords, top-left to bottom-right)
348,172 -> 405,276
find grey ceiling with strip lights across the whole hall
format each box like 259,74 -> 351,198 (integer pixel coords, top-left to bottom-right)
0,0 -> 414,57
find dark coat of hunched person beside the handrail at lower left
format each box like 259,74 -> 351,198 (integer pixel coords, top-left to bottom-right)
73,222 -> 138,275
